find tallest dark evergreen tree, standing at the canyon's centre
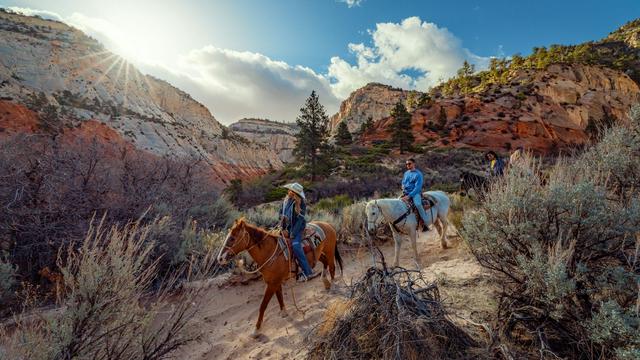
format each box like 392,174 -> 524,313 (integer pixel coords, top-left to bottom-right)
293,90 -> 331,181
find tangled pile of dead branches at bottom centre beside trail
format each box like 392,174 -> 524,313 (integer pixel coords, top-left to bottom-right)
309,264 -> 476,359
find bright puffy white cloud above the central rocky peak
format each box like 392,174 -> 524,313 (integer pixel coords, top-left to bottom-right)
327,17 -> 488,98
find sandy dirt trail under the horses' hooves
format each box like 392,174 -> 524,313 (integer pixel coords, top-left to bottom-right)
175,228 -> 492,360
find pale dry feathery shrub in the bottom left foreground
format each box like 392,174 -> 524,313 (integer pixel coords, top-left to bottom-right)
0,219 -> 211,360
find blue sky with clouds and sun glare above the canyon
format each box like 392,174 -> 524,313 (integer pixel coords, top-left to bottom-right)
0,0 -> 640,124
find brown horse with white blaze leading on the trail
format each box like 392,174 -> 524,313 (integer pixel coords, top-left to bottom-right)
218,218 -> 342,336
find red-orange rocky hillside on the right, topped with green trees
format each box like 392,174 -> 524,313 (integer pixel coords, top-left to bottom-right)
343,20 -> 640,153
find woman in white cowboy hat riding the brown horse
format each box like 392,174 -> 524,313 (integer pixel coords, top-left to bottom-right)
280,183 -> 320,281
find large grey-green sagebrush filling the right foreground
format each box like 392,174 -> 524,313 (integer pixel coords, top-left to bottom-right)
462,109 -> 640,359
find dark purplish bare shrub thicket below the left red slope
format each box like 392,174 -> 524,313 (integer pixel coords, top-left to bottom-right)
0,135 -> 235,310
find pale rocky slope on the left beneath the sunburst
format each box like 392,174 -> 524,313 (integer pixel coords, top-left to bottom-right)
0,11 -> 282,182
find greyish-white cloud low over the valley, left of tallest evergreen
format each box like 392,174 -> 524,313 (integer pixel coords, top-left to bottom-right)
143,46 -> 339,124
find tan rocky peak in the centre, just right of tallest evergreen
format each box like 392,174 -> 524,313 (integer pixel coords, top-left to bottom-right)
329,83 -> 422,133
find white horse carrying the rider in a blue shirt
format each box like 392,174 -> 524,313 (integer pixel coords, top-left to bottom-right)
366,191 -> 451,269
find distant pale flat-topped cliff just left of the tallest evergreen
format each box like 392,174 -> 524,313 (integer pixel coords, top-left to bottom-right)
229,119 -> 298,162
